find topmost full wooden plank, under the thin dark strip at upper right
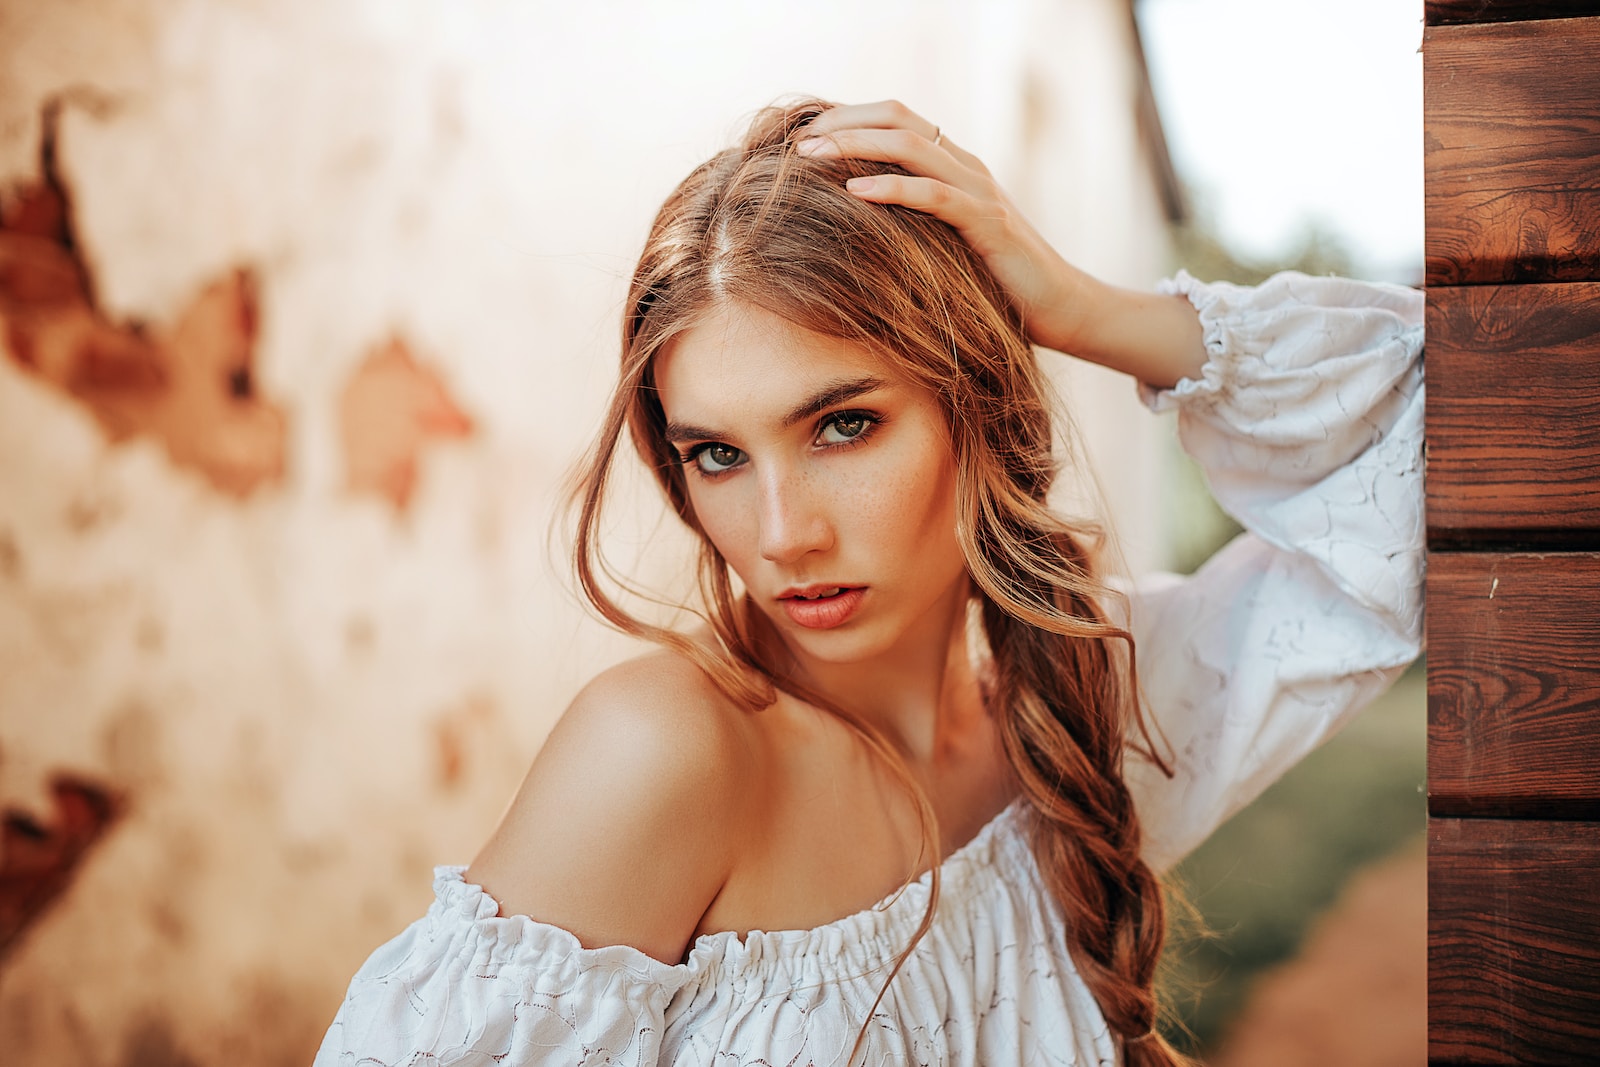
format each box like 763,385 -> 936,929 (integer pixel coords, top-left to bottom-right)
1422,18 -> 1600,285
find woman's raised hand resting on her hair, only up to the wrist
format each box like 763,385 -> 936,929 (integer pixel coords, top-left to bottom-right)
797,101 -> 1088,350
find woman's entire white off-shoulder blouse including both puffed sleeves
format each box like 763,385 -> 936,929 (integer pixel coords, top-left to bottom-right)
317,274 -> 1424,1067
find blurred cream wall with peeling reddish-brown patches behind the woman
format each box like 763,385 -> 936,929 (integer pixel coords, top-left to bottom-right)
0,0 -> 1166,1065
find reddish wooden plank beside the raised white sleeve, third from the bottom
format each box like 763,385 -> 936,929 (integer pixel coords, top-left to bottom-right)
1426,283 -> 1600,537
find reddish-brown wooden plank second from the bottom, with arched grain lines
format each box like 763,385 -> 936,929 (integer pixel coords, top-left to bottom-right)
1427,552 -> 1600,817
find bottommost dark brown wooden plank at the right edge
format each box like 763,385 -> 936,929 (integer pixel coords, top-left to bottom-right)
1427,819 -> 1600,1067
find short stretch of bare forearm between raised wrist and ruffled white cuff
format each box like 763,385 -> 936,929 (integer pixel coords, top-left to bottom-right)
1034,267 -> 1206,389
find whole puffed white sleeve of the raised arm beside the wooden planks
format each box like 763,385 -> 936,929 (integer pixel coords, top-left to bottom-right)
1126,272 -> 1424,870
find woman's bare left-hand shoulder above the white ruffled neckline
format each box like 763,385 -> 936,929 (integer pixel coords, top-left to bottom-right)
467,653 -> 758,963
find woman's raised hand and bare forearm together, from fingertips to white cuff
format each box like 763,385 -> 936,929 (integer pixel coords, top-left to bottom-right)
795,101 -> 1206,386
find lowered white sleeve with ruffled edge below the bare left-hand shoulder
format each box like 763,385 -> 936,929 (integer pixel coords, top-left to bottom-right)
315,867 -> 690,1067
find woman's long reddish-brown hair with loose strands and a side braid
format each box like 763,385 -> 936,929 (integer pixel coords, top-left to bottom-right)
574,101 -> 1186,1067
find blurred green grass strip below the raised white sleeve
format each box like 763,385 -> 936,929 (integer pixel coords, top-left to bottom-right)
1162,662 -> 1427,1056
